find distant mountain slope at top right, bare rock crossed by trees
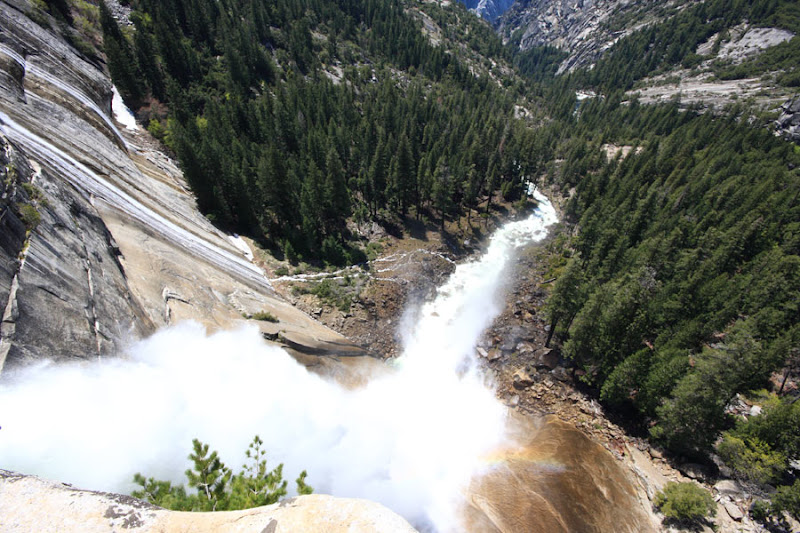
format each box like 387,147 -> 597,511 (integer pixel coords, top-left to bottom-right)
500,0 -> 800,109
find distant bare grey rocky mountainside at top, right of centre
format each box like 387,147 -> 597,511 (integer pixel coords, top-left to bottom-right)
497,0 -> 684,73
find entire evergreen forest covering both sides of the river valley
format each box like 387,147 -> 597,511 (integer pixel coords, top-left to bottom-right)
89,0 -> 800,519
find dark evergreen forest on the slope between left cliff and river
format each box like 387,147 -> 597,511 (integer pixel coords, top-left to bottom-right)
97,0 -> 541,264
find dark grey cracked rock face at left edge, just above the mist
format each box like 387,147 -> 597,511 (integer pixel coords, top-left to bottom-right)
0,135 -> 153,369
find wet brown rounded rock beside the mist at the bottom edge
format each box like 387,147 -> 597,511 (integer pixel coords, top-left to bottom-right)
464,417 -> 658,533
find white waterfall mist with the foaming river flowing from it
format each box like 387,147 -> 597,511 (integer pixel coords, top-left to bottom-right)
0,193 -> 556,531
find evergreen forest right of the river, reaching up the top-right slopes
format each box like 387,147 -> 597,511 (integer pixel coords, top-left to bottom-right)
514,0 -> 800,521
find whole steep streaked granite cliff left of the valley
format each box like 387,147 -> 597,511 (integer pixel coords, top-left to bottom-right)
0,0 -> 358,371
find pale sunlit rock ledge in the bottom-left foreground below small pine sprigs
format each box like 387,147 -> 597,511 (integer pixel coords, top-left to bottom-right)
0,470 -> 416,533
